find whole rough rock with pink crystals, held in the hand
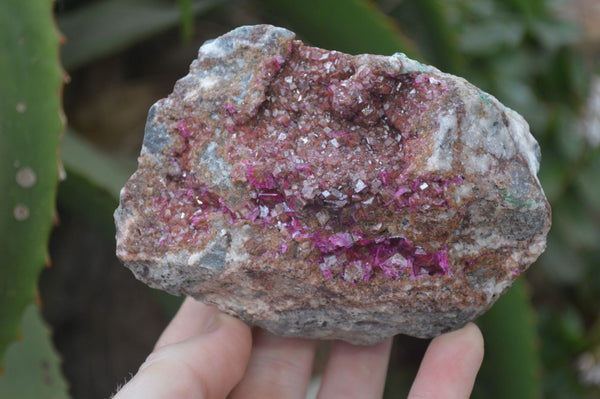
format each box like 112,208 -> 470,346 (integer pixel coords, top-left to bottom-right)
115,25 -> 550,344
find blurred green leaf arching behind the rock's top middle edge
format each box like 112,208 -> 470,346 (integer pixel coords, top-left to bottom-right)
262,0 -> 416,58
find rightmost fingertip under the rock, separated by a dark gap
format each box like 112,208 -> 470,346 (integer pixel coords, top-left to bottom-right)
408,323 -> 483,399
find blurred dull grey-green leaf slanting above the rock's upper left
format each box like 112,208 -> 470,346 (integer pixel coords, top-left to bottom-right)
58,0 -> 223,70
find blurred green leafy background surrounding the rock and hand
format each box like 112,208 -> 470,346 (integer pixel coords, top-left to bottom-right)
0,0 -> 600,399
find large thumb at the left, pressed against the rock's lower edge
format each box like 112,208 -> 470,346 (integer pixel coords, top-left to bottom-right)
115,301 -> 251,399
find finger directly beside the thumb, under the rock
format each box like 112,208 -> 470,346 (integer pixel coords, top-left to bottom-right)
230,329 -> 316,399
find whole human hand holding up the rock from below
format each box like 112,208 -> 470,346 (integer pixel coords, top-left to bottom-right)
114,298 -> 483,399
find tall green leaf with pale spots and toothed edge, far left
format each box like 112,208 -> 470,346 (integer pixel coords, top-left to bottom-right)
0,0 -> 63,366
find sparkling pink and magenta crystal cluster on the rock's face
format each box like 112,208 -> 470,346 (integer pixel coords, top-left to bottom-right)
146,42 -> 462,283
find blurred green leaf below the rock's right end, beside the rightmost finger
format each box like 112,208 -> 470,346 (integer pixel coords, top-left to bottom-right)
472,278 -> 541,399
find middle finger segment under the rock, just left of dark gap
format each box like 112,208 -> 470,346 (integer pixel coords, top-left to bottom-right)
318,338 -> 392,399
